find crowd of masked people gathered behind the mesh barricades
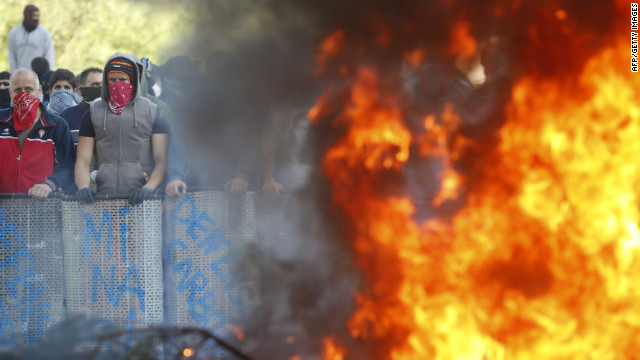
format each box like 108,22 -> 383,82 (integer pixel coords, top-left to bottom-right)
0,5 -> 318,205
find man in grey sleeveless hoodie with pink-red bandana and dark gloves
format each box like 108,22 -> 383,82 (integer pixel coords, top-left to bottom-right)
75,52 -> 168,205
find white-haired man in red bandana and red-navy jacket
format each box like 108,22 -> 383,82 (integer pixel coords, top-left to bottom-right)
0,69 -> 75,199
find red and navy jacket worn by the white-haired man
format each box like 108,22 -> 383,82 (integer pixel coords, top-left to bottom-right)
0,106 -> 75,193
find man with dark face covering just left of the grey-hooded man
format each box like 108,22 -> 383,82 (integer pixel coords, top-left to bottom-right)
60,67 -> 103,146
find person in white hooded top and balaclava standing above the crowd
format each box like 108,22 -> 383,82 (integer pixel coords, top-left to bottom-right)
7,5 -> 55,72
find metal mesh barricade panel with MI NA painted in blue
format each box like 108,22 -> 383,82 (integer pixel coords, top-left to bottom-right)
62,200 -> 163,328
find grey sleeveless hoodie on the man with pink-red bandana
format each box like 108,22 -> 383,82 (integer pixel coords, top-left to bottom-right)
90,52 -> 158,195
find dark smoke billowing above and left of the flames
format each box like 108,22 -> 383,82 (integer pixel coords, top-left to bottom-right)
156,0 -> 616,358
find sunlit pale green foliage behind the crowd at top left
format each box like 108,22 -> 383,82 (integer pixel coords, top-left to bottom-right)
0,0 -> 190,74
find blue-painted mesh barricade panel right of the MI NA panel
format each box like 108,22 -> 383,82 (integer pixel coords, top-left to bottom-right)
164,191 -> 260,340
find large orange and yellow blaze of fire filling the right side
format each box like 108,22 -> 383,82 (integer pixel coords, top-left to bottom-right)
312,3 -> 640,360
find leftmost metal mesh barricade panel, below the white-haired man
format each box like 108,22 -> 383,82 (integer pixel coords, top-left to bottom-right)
0,197 -> 64,349
